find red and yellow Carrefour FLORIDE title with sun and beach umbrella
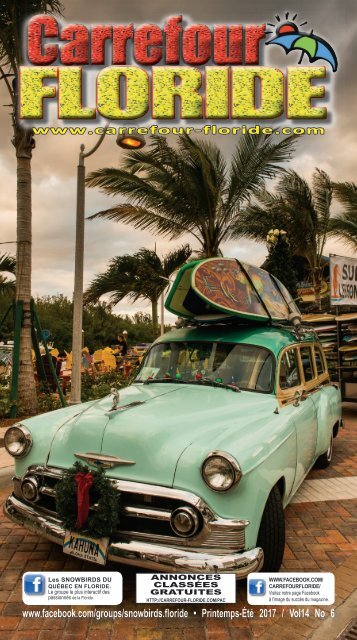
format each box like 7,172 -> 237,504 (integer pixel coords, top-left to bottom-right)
19,13 -> 337,124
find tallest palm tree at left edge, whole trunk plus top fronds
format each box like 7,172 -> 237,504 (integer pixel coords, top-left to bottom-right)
0,0 -> 62,414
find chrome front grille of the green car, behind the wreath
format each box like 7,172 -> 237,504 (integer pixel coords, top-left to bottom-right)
14,466 -> 248,554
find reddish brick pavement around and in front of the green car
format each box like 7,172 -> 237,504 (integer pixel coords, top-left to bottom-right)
0,406 -> 357,640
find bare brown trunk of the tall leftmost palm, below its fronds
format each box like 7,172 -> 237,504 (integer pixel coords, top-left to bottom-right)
13,125 -> 37,415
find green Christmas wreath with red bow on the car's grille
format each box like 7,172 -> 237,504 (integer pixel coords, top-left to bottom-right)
56,462 -> 120,538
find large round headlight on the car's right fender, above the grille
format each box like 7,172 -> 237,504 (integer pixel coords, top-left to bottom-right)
202,451 -> 242,491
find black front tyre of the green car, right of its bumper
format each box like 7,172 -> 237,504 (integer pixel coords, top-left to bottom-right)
257,486 -> 285,571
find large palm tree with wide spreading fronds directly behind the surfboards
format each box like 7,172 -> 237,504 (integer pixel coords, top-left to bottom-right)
87,135 -> 295,257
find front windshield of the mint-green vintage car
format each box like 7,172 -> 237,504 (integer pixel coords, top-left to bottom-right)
135,342 -> 274,393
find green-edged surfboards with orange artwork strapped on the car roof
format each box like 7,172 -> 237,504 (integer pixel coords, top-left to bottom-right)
165,258 -> 299,322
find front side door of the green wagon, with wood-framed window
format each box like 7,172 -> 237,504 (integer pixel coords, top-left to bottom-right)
279,345 -> 317,491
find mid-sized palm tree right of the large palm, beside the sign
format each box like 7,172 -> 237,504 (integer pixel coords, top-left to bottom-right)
236,169 -> 332,308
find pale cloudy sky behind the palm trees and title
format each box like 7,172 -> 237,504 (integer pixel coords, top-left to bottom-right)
0,0 -> 357,320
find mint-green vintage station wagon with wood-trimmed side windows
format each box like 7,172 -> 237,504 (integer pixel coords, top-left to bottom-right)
4,258 -> 341,578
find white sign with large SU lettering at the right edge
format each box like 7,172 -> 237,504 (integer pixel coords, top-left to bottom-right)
330,255 -> 357,306
